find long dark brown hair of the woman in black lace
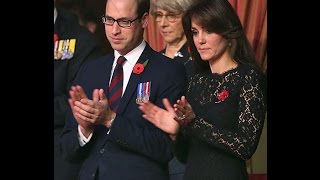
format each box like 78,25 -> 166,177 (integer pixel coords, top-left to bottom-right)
182,0 -> 256,72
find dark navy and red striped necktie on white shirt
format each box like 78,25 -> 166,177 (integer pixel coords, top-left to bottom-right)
109,56 -> 126,112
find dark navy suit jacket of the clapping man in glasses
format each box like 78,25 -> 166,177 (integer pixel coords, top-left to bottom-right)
61,44 -> 187,180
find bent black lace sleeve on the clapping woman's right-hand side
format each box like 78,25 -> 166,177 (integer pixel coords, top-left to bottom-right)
188,70 -> 266,160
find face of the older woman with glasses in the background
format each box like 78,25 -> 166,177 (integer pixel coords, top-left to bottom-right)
155,8 -> 185,44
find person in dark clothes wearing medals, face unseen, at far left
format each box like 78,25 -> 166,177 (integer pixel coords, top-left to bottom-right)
54,4 -> 102,180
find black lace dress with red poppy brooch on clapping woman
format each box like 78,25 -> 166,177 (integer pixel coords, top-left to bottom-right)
175,64 -> 266,180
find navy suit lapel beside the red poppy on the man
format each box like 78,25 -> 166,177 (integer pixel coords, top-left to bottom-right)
117,44 -> 152,113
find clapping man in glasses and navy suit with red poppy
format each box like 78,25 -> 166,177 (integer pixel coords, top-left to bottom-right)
62,0 -> 187,180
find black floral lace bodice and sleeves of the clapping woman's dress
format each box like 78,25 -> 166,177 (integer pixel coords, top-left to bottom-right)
186,65 -> 266,160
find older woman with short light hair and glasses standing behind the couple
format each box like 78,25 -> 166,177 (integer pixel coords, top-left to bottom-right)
152,0 -> 195,77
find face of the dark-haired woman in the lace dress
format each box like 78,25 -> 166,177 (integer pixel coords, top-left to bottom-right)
191,20 -> 228,61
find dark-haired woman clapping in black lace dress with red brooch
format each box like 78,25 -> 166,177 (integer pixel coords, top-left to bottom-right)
140,0 -> 266,180
